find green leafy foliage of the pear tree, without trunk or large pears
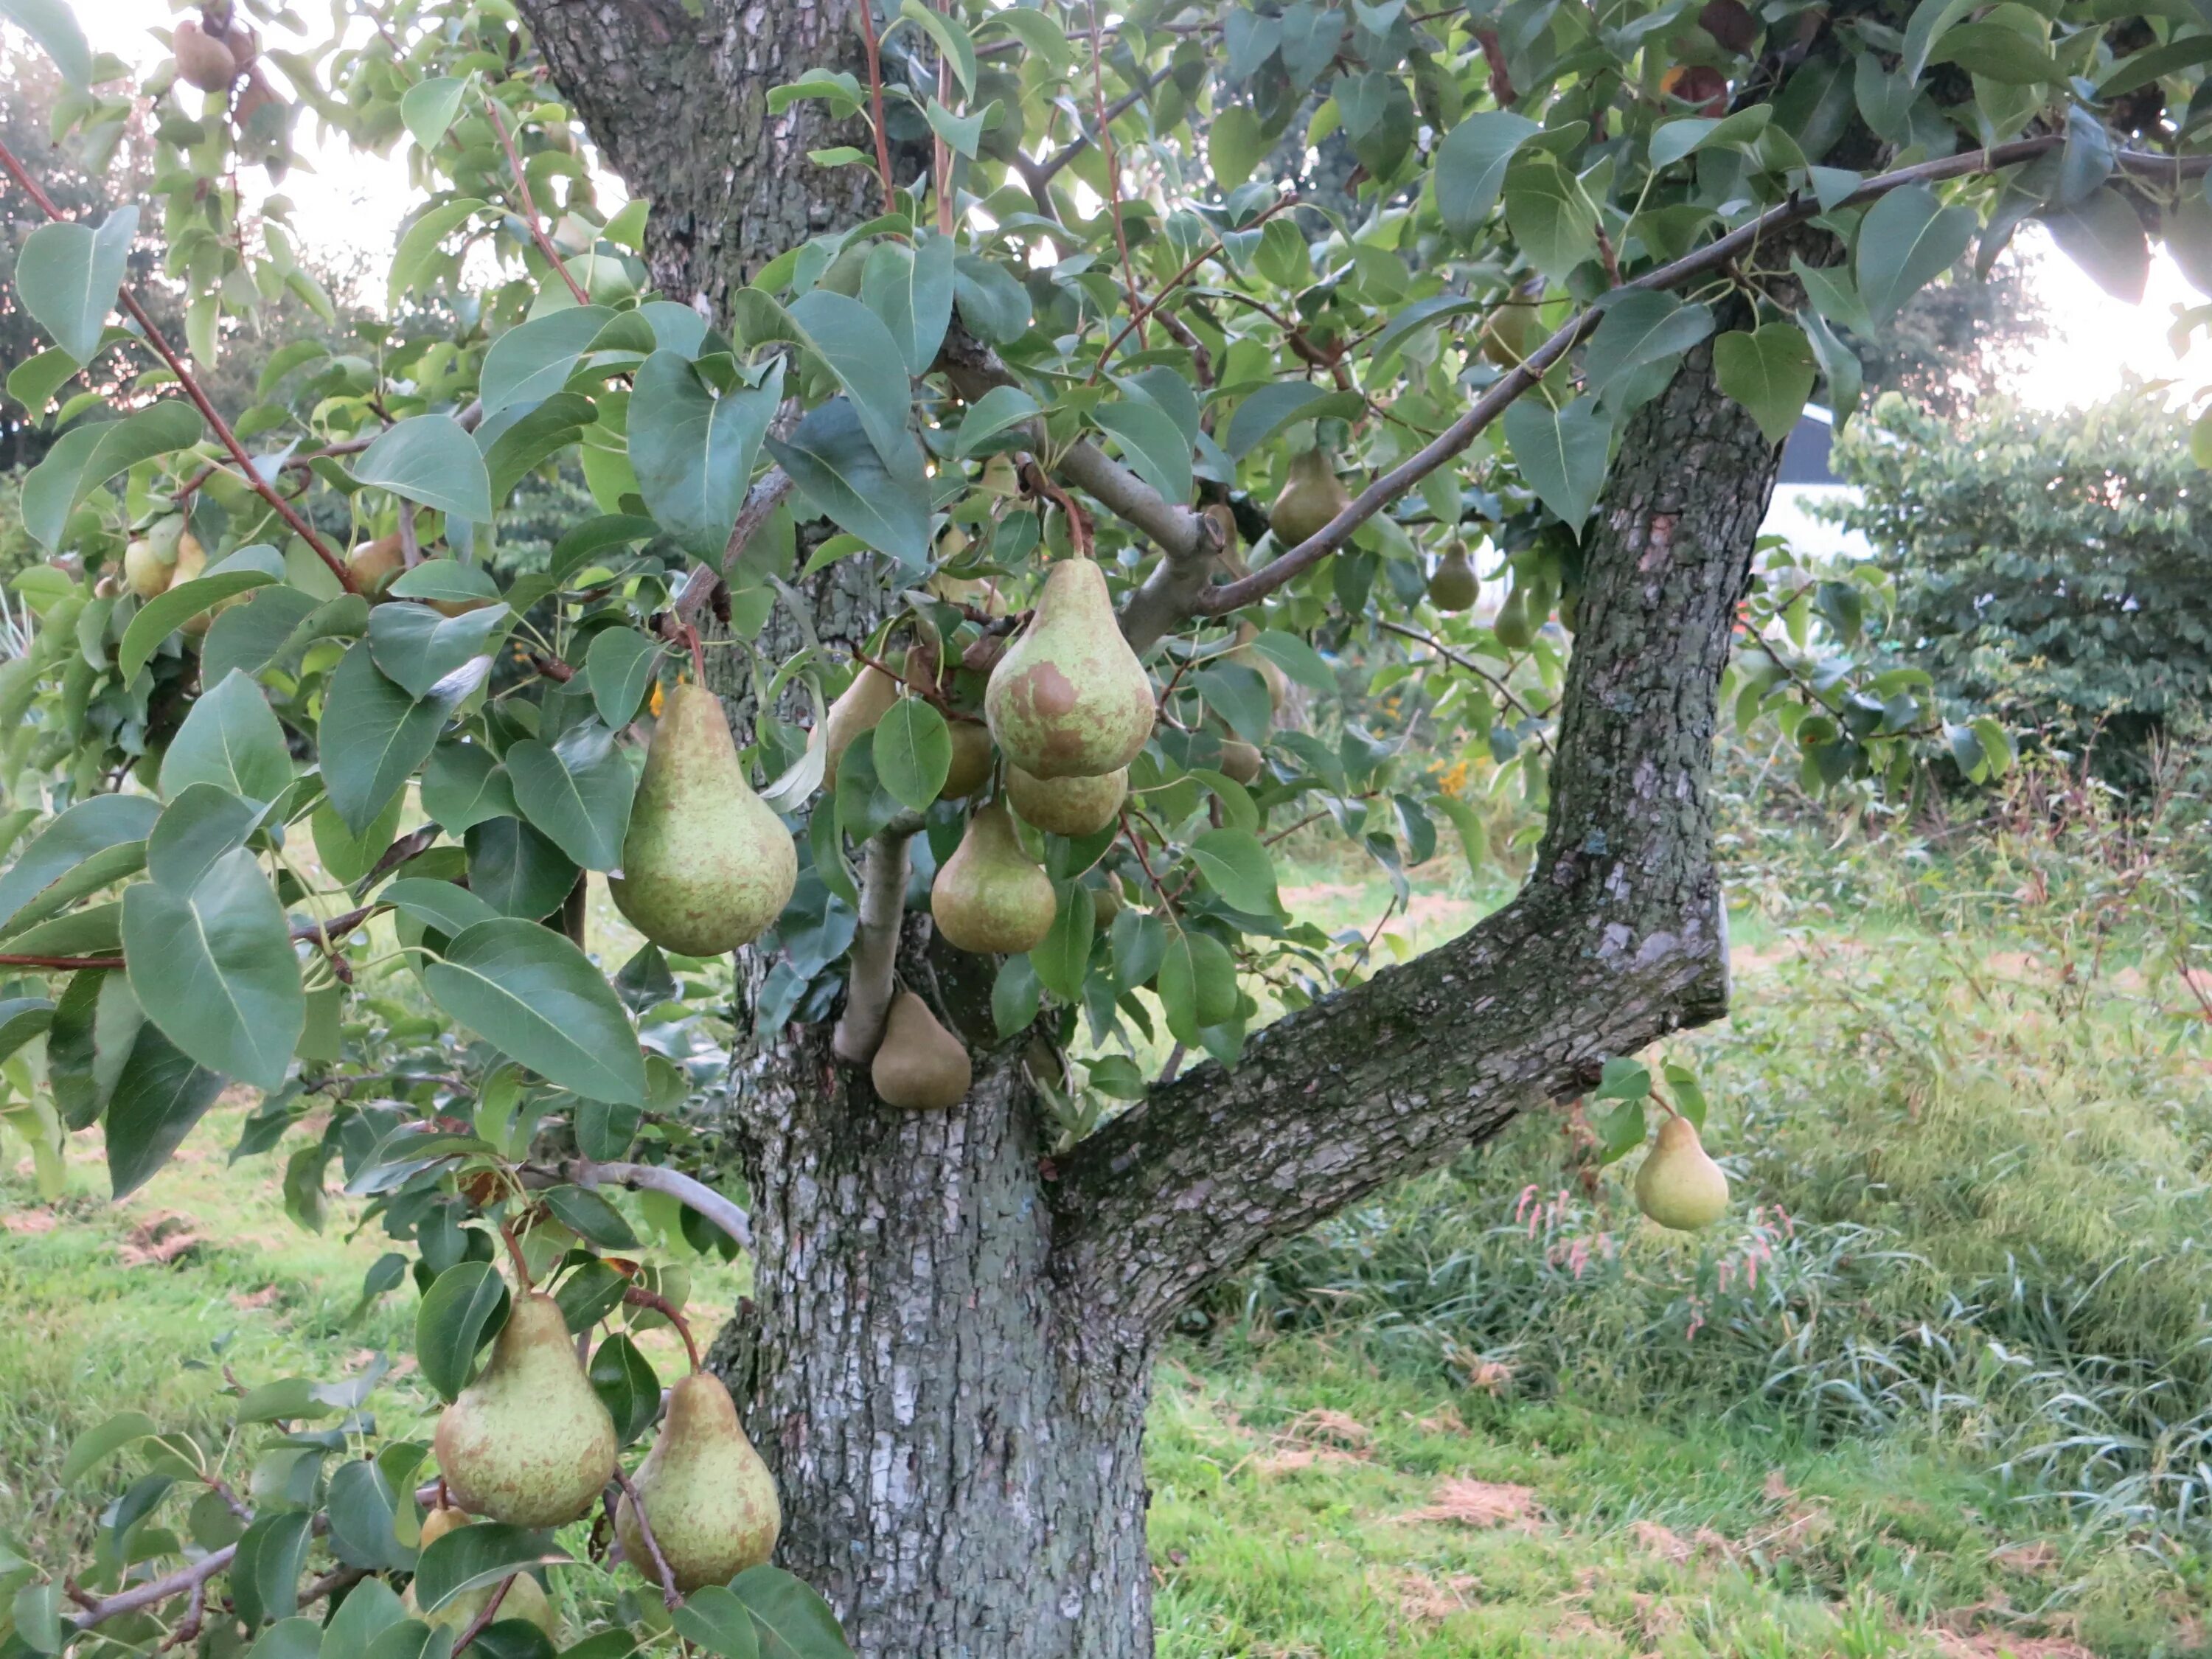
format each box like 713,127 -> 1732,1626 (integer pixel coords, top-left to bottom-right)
0,0 -> 2212,1659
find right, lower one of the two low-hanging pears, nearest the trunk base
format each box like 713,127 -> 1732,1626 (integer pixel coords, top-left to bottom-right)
615,1371 -> 783,1595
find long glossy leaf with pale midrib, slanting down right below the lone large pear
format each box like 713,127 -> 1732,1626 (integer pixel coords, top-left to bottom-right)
422,918 -> 646,1106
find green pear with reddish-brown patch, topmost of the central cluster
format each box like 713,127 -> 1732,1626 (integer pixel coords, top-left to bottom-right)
982,557 -> 1152,779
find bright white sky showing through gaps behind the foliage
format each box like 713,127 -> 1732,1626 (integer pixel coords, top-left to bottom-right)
71,0 -> 2212,409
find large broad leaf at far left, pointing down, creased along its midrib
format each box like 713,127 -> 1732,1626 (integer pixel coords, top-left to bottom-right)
124,847 -> 307,1091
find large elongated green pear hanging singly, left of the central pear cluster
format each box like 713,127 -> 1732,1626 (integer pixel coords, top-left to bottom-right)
606,686 -> 799,956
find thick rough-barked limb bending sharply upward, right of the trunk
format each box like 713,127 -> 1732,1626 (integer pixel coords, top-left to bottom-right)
1057,332 -> 1776,1329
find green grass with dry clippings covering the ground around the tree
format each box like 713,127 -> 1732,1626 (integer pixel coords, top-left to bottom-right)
0,787 -> 2212,1659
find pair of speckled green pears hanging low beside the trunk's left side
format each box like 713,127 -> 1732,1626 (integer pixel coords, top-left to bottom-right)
422,1296 -> 783,1584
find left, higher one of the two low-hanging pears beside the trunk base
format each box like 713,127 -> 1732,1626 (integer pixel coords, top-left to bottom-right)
436,1296 -> 615,1526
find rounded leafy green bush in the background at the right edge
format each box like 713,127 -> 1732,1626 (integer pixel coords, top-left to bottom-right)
1836,387 -> 2212,779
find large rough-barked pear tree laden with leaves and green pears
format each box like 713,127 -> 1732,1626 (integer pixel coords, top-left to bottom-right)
0,0 -> 2212,1659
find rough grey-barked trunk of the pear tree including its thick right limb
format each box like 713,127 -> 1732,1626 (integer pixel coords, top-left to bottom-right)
524,0 -> 1778,1659
